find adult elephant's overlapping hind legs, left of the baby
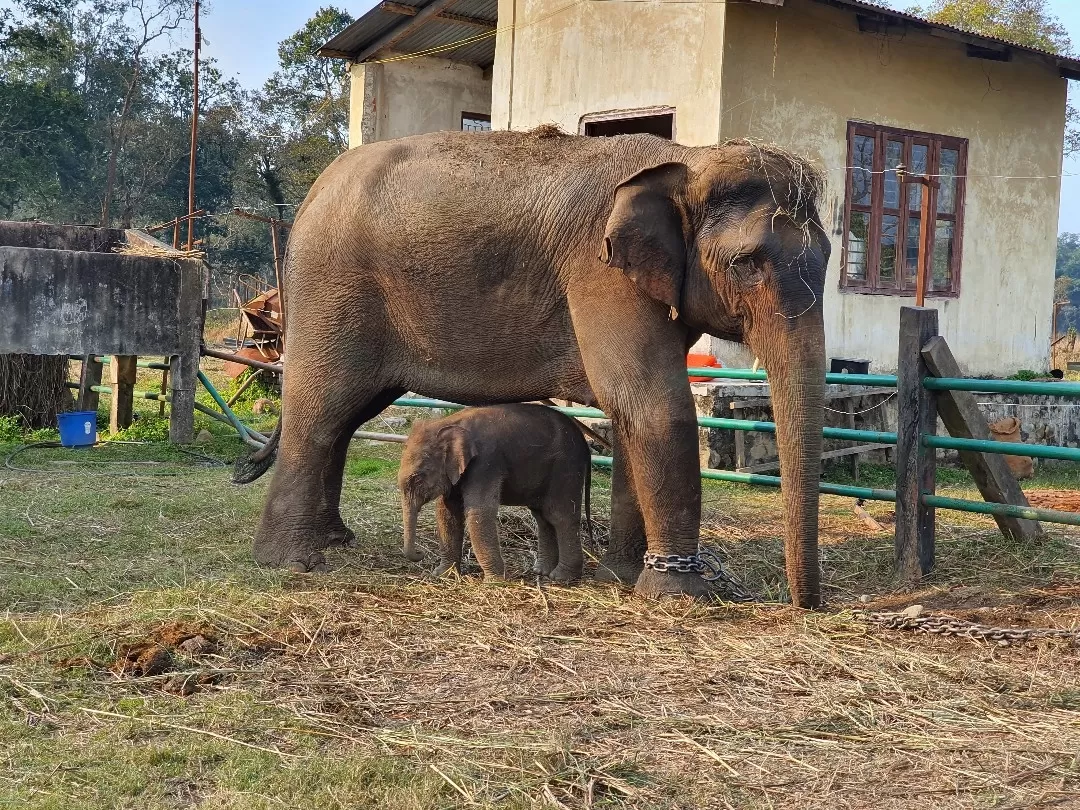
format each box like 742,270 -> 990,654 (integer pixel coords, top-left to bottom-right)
254,384 -> 402,571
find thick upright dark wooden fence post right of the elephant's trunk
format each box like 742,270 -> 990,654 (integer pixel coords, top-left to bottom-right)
895,307 -> 937,583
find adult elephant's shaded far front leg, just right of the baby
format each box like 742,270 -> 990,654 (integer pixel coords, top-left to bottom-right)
596,421 -> 646,585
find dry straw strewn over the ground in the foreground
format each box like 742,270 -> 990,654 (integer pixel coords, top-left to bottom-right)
46,570 -> 1080,810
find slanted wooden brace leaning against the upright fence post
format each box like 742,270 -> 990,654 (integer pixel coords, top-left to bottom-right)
922,337 -> 1041,540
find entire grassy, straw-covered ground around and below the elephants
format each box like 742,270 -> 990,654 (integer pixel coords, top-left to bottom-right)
0,373 -> 1080,810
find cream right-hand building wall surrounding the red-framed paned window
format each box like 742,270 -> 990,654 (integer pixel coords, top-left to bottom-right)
720,0 -> 1066,375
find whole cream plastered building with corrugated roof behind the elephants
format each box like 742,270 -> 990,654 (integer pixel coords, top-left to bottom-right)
321,0 -> 1080,376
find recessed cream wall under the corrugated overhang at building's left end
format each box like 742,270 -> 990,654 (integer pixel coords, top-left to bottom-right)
349,56 -> 491,147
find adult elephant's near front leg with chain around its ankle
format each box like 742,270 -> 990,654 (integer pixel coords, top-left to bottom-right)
627,403 -> 708,597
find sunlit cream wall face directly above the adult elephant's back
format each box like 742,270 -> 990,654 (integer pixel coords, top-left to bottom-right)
491,0 -> 726,144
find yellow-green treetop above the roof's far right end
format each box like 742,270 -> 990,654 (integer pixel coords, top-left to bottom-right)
908,0 -> 1080,154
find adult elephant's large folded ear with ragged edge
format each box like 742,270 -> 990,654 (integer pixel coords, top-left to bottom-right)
600,162 -> 689,311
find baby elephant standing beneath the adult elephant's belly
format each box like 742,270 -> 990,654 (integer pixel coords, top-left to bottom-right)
397,405 -> 592,582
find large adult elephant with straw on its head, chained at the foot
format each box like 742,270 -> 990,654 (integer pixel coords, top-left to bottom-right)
237,127 -> 829,607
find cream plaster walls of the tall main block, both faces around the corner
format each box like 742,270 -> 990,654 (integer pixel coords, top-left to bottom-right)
492,0 -> 1066,374
